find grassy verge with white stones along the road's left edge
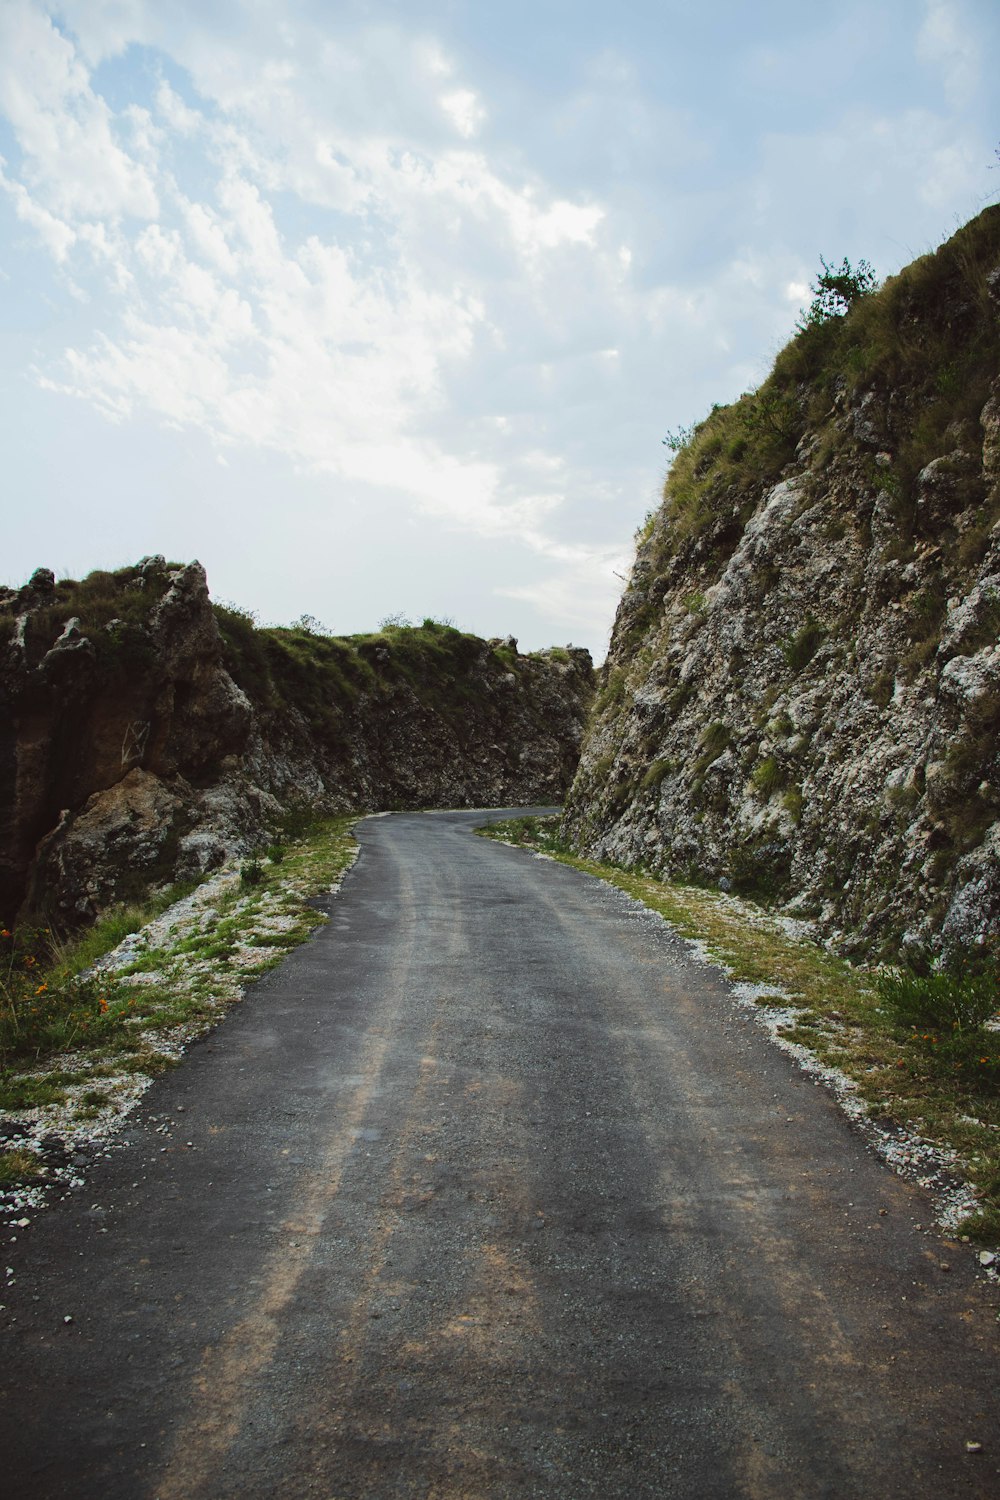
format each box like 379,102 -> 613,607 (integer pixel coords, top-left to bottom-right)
0,816 -> 357,1140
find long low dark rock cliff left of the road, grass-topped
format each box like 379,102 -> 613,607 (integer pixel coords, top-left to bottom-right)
0,557 -> 592,927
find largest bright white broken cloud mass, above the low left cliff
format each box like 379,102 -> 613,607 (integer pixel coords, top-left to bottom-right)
0,11 -> 622,579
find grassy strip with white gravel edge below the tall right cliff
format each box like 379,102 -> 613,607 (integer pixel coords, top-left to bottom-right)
480,818 -> 1000,1244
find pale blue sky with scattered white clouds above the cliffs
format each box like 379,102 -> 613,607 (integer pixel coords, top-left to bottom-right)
0,0 -> 1000,660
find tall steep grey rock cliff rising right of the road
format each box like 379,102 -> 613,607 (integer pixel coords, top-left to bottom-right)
564,209 -> 1000,954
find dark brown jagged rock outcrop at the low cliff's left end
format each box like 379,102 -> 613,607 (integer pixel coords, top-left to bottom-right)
0,558 -> 252,918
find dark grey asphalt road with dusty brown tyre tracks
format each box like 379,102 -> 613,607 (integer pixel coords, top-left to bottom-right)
0,813 -> 1000,1500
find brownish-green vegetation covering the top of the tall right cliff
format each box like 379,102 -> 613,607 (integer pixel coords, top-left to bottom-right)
648,207 -> 1000,563
